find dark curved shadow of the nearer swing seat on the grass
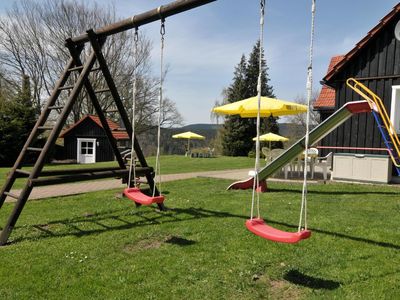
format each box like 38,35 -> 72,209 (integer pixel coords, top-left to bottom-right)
283,270 -> 340,290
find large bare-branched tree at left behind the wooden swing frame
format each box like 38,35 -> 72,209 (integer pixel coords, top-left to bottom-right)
0,0 -> 182,133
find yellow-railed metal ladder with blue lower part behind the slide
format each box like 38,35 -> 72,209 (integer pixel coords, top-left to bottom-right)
346,78 -> 400,176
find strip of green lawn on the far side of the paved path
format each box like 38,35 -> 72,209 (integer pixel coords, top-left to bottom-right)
0,155 -> 254,188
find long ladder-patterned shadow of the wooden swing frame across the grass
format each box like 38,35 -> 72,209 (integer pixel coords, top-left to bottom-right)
10,207 -> 400,250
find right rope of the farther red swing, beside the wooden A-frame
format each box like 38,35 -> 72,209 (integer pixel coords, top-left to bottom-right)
153,18 -> 165,197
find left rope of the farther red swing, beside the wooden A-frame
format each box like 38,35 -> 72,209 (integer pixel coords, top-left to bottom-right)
128,27 -> 139,187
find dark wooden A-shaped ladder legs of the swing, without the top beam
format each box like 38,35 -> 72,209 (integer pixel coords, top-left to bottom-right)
0,30 -> 159,245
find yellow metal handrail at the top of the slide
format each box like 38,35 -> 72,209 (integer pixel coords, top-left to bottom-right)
346,78 -> 400,167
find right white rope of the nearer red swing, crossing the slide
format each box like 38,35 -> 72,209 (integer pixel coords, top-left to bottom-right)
298,0 -> 316,231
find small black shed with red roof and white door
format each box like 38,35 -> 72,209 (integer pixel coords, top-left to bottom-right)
60,115 -> 130,163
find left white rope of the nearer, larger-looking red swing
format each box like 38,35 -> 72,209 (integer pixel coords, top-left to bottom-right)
250,0 -> 265,219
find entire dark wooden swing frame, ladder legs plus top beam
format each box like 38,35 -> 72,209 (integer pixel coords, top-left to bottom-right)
0,0 -> 216,246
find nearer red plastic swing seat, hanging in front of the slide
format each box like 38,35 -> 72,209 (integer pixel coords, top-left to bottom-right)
246,218 -> 311,244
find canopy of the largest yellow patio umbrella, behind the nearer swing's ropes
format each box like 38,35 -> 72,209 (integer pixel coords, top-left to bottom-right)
213,97 -> 307,118
